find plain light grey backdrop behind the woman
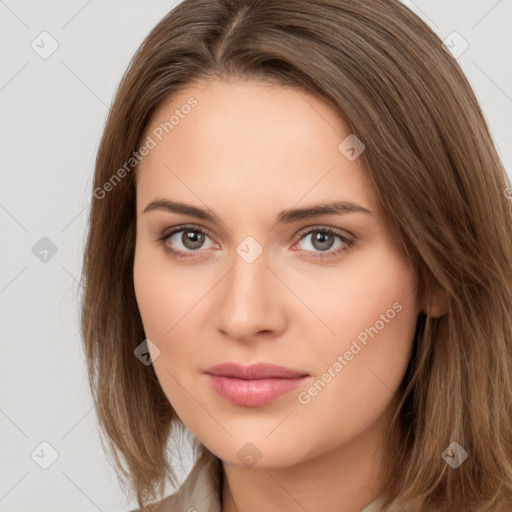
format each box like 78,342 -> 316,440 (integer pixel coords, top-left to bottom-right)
0,0 -> 512,512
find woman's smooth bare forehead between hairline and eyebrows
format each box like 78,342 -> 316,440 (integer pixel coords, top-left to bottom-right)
137,79 -> 377,216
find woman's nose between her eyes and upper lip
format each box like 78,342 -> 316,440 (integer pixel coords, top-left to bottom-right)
215,246 -> 287,341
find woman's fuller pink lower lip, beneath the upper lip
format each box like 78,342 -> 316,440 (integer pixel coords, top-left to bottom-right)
206,374 -> 309,407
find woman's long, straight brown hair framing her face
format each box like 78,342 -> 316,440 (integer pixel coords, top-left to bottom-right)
81,0 -> 512,512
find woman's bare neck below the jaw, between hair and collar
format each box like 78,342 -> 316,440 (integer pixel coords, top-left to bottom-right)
222,400 -> 398,512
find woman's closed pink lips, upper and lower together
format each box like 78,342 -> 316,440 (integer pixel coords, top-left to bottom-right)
204,363 -> 310,407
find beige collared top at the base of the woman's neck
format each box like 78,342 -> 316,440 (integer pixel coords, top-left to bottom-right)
149,453 -> 388,512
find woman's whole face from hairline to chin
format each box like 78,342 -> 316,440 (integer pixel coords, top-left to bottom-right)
134,79 -> 420,467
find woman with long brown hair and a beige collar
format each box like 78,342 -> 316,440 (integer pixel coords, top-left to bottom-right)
82,0 -> 512,512
